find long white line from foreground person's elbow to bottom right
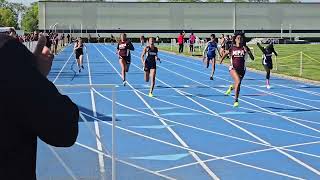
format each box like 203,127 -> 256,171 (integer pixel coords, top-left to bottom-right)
81,112 -> 302,180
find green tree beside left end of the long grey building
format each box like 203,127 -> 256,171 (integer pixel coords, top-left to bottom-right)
22,3 -> 39,32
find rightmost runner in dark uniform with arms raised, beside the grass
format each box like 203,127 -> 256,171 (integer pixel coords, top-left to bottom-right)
257,43 -> 278,89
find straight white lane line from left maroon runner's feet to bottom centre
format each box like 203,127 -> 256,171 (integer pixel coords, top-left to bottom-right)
95,46 -> 219,180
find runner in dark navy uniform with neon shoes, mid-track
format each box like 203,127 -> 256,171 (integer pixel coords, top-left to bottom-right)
141,38 -> 161,97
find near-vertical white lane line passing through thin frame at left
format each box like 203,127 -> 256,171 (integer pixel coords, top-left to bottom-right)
86,45 -> 105,179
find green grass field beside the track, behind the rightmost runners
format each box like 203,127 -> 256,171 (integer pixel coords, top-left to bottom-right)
159,44 -> 320,81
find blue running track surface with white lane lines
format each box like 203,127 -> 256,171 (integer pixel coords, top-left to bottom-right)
37,44 -> 320,180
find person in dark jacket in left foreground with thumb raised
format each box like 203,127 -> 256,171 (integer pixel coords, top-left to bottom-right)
0,34 -> 79,180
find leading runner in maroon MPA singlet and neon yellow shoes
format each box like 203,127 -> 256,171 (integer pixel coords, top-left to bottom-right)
220,34 -> 254,107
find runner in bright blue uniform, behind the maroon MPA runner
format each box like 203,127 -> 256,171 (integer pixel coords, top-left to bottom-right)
203,34 -> 221,80
